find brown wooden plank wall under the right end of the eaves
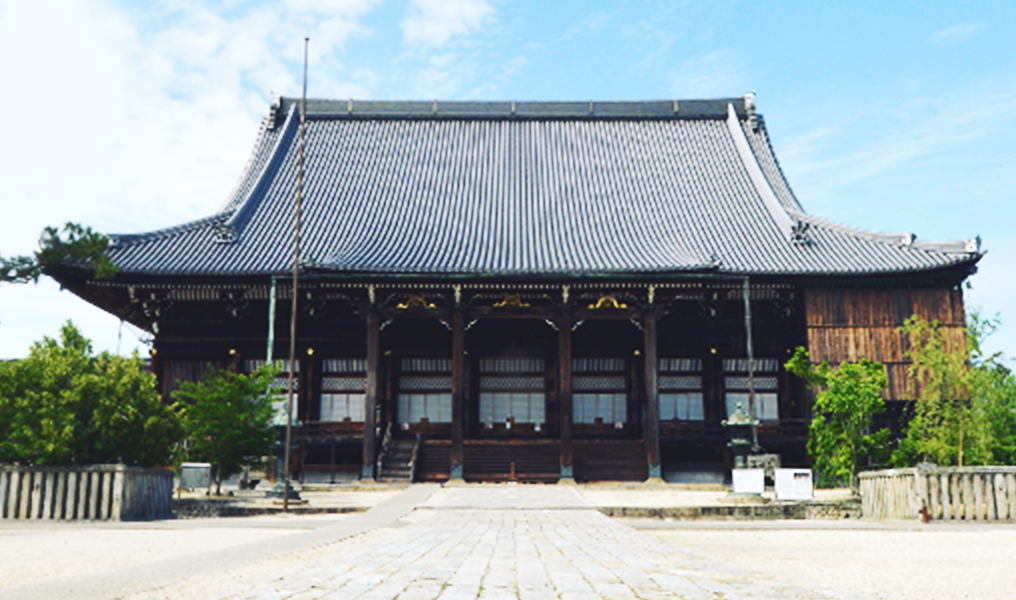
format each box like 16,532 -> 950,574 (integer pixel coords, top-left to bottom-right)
805,289 -> 965,400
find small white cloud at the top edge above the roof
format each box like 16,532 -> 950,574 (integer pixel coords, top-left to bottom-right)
402,0 -> 494,46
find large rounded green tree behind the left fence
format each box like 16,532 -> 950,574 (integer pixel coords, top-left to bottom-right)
0,322 -> 182,467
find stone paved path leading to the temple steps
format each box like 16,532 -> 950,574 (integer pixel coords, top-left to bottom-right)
188,485 -> 855,600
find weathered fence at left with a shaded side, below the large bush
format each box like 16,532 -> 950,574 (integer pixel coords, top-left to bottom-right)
0,465 -> 173,521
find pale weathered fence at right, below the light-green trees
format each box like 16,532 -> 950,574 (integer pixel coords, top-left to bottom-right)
861,467 -> 1016,521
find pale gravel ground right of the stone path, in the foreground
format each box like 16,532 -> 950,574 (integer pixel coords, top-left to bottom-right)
630,521 -> 1016,600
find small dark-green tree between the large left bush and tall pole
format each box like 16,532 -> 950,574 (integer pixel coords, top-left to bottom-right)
173,366 -> 277,494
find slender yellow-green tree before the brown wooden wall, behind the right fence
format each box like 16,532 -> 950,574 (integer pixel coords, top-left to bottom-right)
893,315 -> 993,467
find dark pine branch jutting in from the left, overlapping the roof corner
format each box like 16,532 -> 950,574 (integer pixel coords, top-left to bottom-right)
0,223 -> 117,283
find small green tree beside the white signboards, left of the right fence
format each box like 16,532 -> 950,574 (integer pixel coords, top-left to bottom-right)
786,347 -> 890,489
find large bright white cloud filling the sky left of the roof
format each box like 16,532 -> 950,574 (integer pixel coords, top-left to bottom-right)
0,0 -> 378,357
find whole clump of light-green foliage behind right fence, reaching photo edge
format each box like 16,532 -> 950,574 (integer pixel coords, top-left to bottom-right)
893,314 -> 1016,466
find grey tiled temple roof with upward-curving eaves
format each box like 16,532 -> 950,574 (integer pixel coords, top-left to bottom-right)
110,96 -> 980,277
